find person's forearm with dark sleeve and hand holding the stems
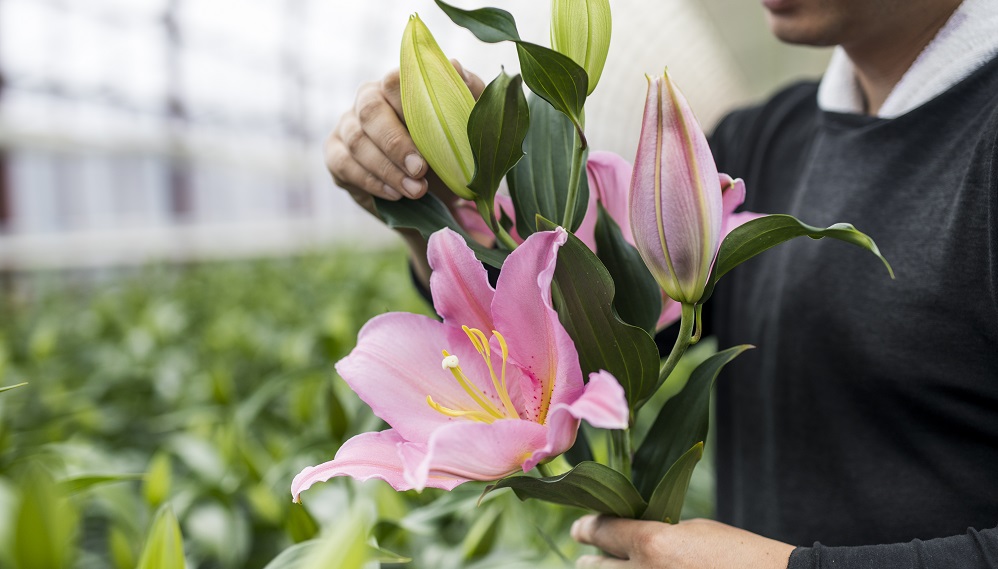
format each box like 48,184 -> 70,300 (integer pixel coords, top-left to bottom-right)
572,516 -> 998,569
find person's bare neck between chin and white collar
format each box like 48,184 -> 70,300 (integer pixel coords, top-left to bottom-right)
842,1 -> 960,115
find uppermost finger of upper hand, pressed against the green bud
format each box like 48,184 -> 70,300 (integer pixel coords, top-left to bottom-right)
351,80 -> 428,181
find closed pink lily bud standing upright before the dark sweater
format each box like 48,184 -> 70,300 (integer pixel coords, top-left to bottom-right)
629,71 -> 722,304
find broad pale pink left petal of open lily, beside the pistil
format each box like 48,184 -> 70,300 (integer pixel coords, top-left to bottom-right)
336,312 -> 501,442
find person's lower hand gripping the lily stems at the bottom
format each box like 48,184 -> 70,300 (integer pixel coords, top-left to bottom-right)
572,516 -> 794,569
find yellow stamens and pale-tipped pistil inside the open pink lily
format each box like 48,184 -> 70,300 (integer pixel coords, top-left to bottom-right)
426,326 -> 520,423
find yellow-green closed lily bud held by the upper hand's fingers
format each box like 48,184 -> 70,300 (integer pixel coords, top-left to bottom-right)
399,14 -> 475,200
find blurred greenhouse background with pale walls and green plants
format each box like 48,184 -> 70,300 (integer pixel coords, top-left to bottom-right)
0,0 -> 829,568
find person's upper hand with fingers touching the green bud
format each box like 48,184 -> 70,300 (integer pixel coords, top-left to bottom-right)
325,61 -> 485,215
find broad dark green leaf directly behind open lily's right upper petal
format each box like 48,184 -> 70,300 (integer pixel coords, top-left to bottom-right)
537,214 -> 659,409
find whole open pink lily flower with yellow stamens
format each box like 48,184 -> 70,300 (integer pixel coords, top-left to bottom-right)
291,228 -> 629,501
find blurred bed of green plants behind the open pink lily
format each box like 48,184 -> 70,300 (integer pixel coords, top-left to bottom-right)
0,250 -> 712,569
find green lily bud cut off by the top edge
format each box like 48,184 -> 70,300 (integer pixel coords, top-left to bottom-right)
551,0 -> 612,94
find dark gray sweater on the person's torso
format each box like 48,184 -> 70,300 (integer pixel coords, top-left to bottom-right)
710,52 -> 998,569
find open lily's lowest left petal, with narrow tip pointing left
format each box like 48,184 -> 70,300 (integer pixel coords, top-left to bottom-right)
291,429 -> 466,502
